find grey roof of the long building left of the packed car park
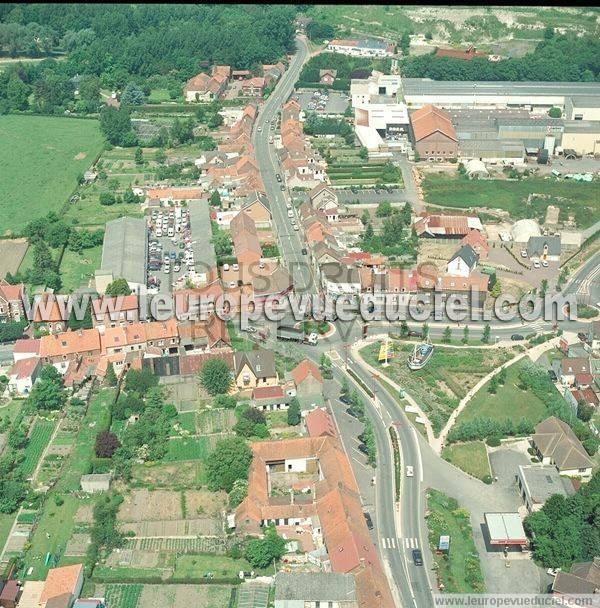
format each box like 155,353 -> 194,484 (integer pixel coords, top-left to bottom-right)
102,217 -> 148,284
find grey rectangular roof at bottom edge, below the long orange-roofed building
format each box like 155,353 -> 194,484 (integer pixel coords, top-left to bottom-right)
275,572 -> 356,602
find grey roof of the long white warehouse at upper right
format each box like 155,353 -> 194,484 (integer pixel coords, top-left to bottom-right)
402,78 -> 600,99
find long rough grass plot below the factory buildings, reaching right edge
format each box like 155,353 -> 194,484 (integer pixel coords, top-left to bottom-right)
423,173 -> 600,228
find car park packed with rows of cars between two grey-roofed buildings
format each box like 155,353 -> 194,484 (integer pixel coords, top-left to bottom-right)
147,205 -> 194,293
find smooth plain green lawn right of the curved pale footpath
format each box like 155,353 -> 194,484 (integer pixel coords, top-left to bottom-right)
456,360 -> 546,425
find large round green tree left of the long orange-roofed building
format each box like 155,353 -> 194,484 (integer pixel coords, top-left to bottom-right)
206,437 -> 252,492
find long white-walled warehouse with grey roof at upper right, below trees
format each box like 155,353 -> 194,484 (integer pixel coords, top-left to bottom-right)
402,78 -> 600,112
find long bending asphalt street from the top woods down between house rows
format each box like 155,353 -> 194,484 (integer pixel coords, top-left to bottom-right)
252,37 -> 315,293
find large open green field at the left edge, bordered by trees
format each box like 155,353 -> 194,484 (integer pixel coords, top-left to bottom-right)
0,116 -> 102,233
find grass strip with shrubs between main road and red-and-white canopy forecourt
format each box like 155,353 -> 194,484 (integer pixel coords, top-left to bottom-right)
427,489 -> 485,593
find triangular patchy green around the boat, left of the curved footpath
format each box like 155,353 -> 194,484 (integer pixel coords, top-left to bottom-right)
360,341 -> 514,434
